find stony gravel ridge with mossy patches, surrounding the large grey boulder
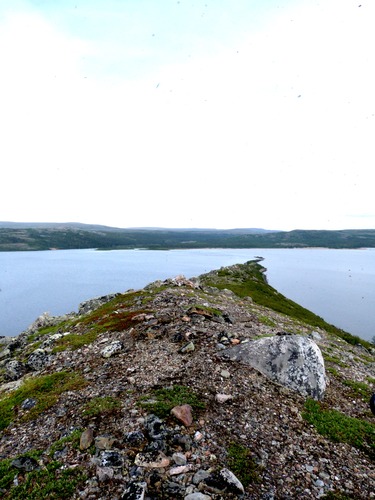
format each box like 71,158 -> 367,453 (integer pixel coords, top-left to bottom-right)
0,265 -> 375,500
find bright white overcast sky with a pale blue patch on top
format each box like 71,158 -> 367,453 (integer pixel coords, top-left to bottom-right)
0,0 -> 375,230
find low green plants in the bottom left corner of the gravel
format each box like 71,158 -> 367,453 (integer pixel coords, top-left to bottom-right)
0,455 -> 86,500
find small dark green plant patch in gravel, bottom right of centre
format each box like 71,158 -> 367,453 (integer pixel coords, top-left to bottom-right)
227,442 -> 260,488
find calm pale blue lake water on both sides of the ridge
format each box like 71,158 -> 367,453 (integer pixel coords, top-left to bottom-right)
0,249 -> 375,339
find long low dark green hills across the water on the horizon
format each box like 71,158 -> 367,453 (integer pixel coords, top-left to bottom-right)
0,222 -> 375,251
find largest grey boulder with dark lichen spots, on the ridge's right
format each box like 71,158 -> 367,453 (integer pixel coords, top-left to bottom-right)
220,335 -> 326,399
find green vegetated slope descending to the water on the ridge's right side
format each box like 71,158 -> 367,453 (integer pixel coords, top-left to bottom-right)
201,260 -> 372,349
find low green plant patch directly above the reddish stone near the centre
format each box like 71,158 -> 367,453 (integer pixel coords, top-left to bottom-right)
139,385 -> 205,418
